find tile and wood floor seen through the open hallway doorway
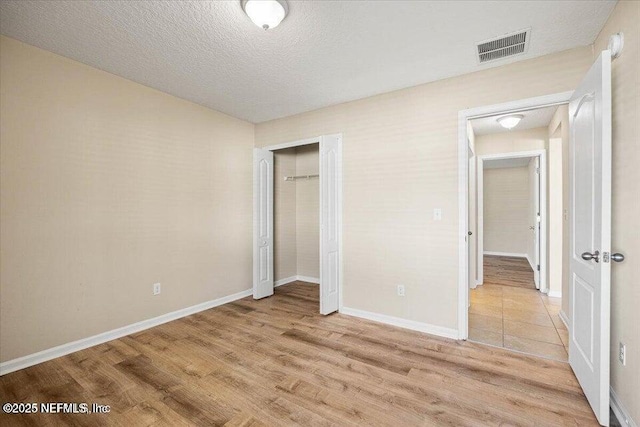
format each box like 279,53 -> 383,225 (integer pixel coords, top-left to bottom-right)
469,256 -> 569,362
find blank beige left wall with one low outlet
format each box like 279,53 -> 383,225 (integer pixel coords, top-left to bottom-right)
0,37 -> 254,361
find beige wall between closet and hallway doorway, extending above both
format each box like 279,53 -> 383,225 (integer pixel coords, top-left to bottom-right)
256,47 -> 592,328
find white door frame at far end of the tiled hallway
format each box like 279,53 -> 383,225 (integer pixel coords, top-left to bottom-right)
476,149 -> 549,293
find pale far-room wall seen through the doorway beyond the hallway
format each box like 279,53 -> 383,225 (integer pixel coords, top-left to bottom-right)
483,167 -> 533,254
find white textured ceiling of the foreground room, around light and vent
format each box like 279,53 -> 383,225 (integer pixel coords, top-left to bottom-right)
0,0 -> 615,122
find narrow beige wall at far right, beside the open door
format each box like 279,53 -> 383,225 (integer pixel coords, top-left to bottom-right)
592,1 -> 640,424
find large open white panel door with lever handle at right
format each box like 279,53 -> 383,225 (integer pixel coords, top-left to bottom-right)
569,50 -> 611,426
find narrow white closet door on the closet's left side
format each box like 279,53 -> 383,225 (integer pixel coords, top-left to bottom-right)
253,148 -> 273,299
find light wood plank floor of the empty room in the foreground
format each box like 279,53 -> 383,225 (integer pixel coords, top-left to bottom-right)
0,282 -> 597,426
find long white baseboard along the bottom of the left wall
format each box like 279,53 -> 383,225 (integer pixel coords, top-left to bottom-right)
0,289 -> 253,376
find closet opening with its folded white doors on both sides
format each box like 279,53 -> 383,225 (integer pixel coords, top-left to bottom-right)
253,134 -> 342,314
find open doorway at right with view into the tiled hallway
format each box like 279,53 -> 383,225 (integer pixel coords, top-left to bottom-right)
468,104 -> 569,362
